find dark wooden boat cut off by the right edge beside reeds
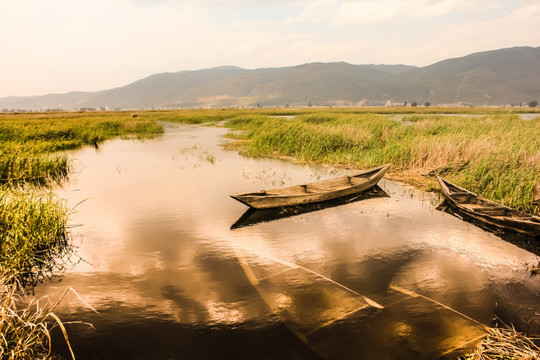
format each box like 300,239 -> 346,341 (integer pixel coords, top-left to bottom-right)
437,177 -> 540,236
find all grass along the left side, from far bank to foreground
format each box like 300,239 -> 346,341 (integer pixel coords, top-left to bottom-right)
0,109 -> 169,359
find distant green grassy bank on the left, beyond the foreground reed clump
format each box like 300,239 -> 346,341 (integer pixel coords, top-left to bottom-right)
0,113 -> 163,185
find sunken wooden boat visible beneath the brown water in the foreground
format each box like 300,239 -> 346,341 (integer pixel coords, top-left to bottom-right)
234,246 -> 488,360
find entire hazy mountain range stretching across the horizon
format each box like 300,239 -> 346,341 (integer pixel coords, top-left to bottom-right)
0,47 -> 540,110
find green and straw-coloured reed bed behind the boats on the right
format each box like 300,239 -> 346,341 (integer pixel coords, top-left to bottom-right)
227,111 -> 540,212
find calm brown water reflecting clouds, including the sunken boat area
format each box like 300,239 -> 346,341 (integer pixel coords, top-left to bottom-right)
36,125 -> 540,359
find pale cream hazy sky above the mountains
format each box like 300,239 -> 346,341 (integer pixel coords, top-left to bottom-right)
0,0 -> 540,97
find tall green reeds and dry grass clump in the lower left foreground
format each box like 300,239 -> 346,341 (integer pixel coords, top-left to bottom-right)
0,189 -> 74,359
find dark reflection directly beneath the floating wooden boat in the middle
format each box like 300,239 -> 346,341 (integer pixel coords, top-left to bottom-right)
231,185 -> 389,229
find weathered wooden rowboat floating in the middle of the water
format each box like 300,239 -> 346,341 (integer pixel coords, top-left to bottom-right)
231,164 -> 390,209
